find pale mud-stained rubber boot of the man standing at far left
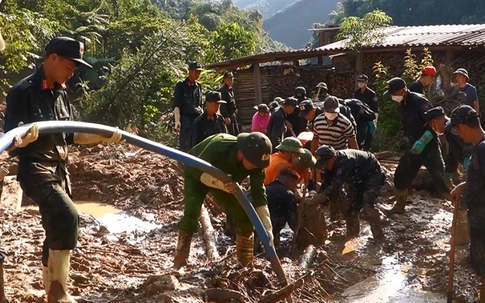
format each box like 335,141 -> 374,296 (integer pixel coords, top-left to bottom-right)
47,250 -> 76,303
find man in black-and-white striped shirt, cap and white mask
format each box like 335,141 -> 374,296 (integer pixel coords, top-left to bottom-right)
311,96 -> 359,154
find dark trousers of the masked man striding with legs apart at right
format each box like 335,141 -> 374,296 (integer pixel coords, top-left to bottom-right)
394,148 -> 449,195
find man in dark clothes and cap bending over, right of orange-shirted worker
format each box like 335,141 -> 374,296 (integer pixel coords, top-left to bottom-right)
314,145 -> 385,242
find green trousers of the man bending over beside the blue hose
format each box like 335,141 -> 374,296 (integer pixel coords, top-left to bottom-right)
178,176 -> 254,234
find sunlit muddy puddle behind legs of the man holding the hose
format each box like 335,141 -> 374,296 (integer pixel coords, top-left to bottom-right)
22,201 -> 160,234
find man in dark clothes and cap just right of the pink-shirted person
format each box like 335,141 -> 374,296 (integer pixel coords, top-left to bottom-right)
266,97 -> 298,146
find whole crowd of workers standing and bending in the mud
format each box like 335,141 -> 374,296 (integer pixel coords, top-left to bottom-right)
0,30 -> 485,302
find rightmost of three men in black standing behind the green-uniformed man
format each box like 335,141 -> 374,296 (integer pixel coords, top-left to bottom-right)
219,72 -> 239,136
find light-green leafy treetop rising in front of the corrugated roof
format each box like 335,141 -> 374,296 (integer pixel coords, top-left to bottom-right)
337,9 -> 392,51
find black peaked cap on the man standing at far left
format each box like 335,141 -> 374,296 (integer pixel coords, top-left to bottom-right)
45,37 -> 92,67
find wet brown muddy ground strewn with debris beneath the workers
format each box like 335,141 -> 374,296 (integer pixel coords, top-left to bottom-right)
0,145 -> 476,303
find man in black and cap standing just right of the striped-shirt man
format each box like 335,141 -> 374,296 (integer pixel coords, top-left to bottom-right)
354,74 -> 379,150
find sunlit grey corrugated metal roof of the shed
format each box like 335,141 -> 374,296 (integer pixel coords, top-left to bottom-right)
317,24 -> 485,51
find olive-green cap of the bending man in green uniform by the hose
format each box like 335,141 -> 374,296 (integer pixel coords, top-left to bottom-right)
237,132 -> 273,168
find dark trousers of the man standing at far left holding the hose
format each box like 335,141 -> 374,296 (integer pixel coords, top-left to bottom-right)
18,168 -> 79,267
